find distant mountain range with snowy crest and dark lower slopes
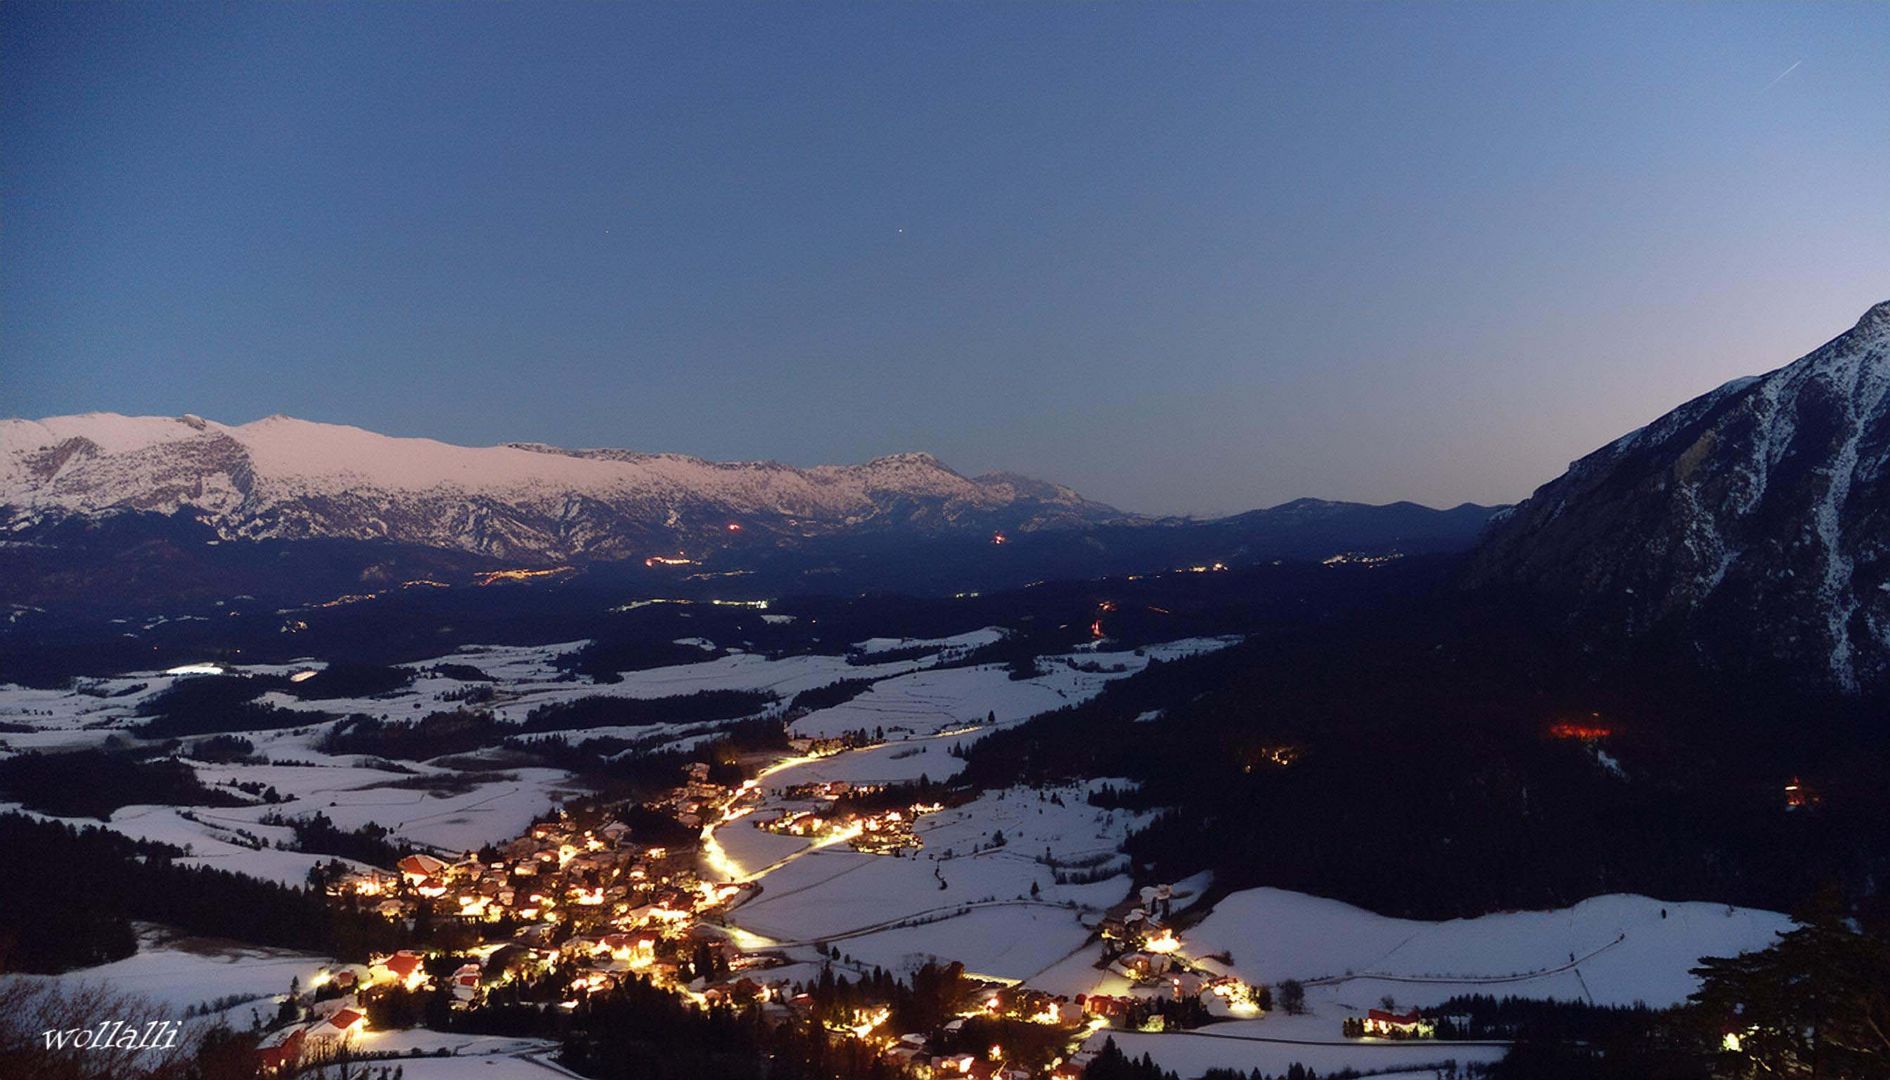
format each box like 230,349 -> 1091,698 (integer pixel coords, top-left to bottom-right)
0,412 -> 1491,586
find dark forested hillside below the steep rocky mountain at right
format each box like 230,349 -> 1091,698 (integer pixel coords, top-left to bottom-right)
966,600 -> 1890,917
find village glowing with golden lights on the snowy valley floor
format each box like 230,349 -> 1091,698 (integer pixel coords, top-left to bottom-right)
259,740 -> 1300,1080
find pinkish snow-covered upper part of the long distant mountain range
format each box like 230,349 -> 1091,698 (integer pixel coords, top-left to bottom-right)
0,412 -> 1125,560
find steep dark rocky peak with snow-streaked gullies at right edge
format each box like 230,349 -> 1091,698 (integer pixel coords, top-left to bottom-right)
1469,301 -> 1890,690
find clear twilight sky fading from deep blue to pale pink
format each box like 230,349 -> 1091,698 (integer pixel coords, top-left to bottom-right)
0,0 -> 1890,513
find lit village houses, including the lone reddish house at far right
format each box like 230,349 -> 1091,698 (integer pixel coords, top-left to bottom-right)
291,730 -> 1330,1080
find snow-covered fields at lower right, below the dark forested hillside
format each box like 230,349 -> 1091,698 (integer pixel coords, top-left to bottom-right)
1092,889 -> 1790,1076
